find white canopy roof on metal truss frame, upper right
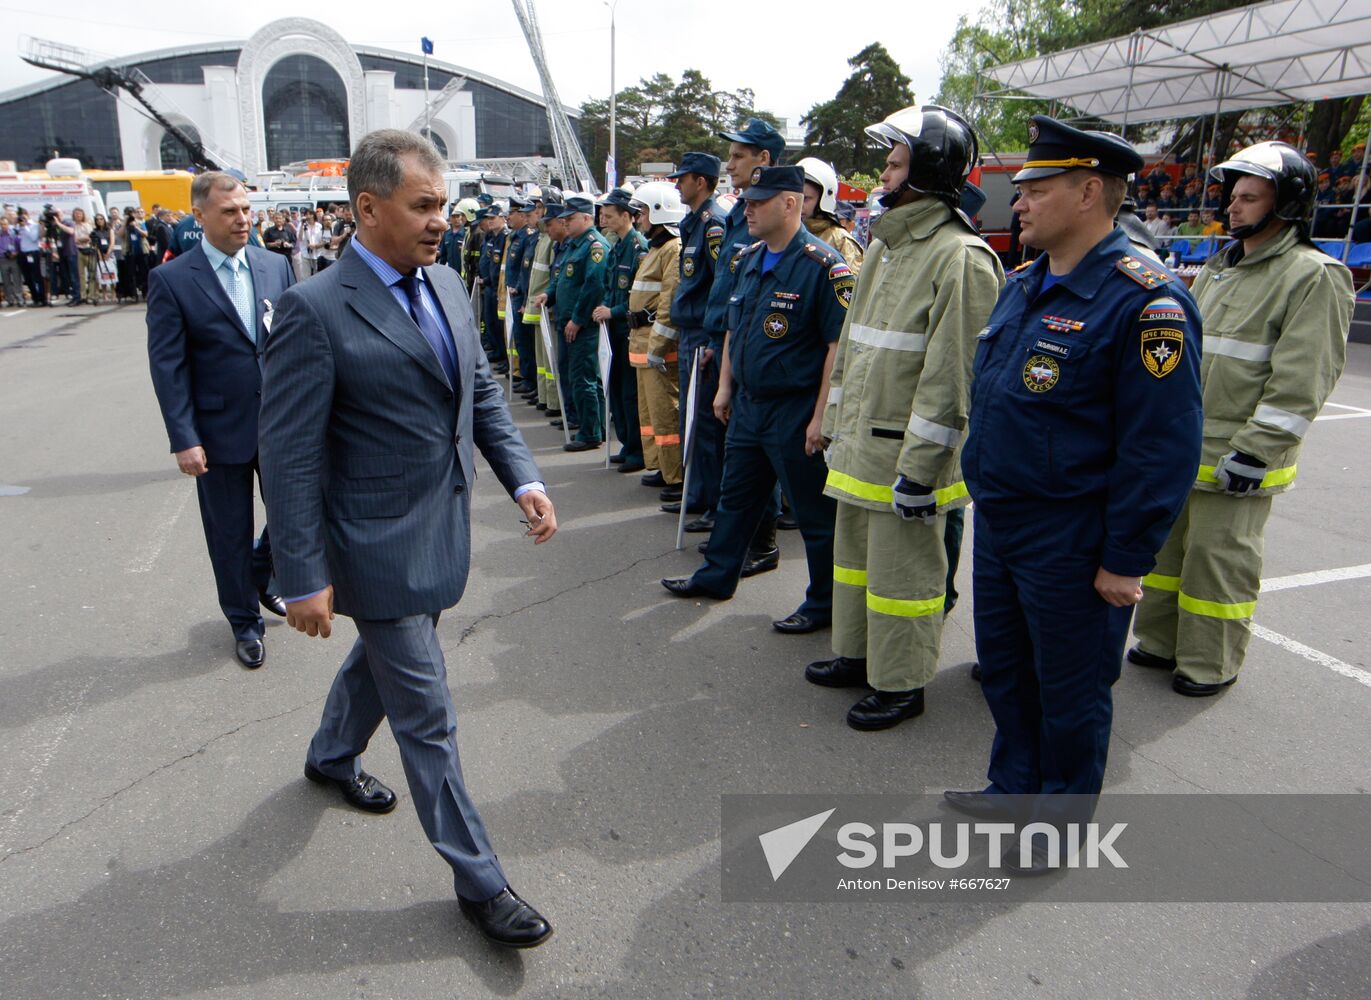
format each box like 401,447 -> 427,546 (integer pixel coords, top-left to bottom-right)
980,0 -> 1371,259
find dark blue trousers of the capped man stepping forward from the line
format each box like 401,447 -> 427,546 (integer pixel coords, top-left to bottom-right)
694,390 -> 836,623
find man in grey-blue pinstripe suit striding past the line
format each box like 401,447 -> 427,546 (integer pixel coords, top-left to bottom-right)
260,129 -> 557,948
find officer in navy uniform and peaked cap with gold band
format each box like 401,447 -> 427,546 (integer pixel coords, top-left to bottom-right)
947,115 -> 1202,871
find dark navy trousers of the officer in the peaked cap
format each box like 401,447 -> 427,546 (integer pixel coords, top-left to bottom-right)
972,503 -> 1132,796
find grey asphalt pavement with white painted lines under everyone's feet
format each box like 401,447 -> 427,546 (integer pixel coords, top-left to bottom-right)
0,306 -> 1371,1000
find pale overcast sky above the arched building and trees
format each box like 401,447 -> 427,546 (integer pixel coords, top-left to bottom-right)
0,0 -> 982,124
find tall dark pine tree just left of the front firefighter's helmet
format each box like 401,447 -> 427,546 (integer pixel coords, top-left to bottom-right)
799,41 -> 914,174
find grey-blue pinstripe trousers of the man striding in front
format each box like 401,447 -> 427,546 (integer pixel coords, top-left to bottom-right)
308,613 -> 509,900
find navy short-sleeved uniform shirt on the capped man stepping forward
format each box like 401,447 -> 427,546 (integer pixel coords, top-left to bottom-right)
716,226 -> 856,399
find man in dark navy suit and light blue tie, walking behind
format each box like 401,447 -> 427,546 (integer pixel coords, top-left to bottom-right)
148,171 -> 295,668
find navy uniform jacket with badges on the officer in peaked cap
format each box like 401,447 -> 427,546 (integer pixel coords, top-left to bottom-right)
961,222 -> 1202,576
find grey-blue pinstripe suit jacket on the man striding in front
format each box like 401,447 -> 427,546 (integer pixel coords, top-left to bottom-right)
260,244 -> 542,619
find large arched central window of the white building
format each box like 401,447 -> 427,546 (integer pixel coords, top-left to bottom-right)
262,55 -> 351,170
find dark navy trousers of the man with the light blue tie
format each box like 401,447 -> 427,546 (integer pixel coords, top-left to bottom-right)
195,455 -> 271,641
